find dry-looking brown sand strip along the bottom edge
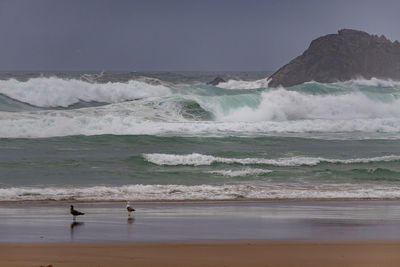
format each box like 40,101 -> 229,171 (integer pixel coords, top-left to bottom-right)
0,240 -> 400,267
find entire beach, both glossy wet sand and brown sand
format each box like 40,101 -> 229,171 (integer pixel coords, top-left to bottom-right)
0,200 -> 400,267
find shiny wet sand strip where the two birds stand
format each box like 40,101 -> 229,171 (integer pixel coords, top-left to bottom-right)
0,200 -> 400,243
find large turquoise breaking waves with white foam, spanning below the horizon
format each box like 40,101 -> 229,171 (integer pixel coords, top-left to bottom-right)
0,78 -> 400,138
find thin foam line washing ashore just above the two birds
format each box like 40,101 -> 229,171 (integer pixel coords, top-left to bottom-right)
0,183 -> 400,201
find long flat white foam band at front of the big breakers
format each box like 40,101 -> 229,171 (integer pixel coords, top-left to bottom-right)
0,109 -> 400,139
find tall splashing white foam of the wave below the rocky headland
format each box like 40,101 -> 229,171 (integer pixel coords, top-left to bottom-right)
216,89 -> 400,122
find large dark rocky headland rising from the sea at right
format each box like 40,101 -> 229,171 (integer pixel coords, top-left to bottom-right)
268,29 -> 400,87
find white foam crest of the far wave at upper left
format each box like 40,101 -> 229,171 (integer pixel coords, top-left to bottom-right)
0,77 -> 171,107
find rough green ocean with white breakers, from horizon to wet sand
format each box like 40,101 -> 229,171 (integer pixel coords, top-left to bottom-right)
0,72 -> 400,201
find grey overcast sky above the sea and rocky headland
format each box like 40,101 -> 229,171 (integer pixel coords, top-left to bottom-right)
0,0 -> 400,71
